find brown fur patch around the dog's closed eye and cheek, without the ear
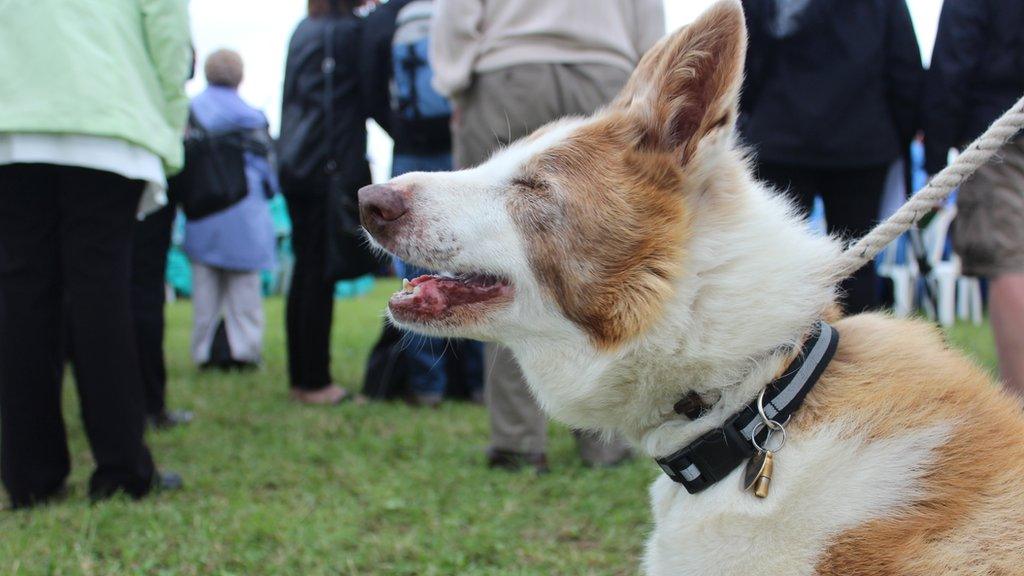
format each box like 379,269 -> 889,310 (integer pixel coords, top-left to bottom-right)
509,115 -> 687,346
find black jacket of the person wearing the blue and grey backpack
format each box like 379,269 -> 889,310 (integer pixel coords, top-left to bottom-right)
359,0 -> 452,155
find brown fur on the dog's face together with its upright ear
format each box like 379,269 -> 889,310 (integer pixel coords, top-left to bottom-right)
501,2 -> 746,348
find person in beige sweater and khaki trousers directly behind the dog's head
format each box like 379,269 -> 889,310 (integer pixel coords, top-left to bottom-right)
430,0 -> 665,471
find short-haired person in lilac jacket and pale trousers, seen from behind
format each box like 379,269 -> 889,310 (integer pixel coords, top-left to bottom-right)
184,50 -> 279,367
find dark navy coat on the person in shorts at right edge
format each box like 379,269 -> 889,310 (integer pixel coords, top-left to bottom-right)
925,0 -> 1024,173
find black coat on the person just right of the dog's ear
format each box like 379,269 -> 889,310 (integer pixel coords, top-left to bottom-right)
740,0 -> 924,168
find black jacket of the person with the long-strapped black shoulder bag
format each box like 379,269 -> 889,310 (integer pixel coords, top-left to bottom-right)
278,16 -> 369,196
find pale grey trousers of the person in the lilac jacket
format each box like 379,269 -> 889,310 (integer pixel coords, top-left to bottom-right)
191,262 -> 265,364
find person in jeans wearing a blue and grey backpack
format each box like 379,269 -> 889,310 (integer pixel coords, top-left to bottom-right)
359,0 -> 483,407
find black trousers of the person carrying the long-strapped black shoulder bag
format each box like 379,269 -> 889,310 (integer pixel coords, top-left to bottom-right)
285,195 -> 334,390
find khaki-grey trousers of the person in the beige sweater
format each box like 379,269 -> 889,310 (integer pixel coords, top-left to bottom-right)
453,64 -> 629,465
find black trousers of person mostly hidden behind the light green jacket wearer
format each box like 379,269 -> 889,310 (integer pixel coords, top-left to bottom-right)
131,205 -> 175,416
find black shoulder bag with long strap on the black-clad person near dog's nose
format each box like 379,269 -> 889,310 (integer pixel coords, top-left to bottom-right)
322,19 -> 380,281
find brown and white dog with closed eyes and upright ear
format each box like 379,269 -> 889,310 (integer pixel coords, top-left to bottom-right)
359,0 -> 1024,576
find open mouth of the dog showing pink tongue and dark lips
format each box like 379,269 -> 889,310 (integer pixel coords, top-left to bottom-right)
388,274 -> 512,323
